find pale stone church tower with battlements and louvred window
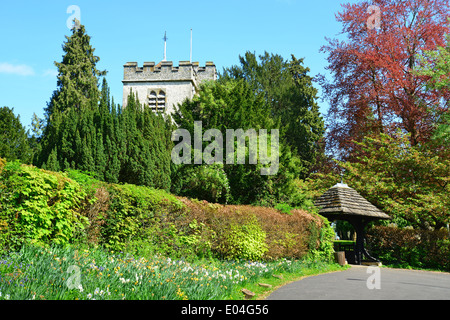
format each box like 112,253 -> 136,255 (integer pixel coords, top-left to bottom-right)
122,61 -> 217,114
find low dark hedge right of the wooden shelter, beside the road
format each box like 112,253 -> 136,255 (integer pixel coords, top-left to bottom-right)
367,226 -> 450,271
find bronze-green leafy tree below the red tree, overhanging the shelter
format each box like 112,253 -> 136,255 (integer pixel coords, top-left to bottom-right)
340,132 -> 450,229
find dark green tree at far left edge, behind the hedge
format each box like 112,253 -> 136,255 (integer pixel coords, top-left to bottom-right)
0,107 -> 32,163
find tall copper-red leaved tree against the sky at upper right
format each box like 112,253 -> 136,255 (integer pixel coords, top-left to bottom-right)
319,0 -> 450,160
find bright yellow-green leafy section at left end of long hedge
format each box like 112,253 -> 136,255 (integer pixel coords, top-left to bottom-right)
0,162 -> 87,249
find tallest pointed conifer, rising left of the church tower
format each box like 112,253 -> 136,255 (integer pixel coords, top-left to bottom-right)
36,25 -> 106,175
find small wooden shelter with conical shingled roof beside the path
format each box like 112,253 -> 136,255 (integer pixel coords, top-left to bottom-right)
315,181 -> 391,264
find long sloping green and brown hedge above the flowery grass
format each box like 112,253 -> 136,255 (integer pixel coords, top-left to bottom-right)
0,161 -> 334,260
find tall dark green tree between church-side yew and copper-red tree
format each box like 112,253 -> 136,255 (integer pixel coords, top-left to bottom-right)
220,52 -> 325,177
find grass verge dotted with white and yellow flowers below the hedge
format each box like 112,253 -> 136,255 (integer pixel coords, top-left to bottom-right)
0,246 -> 343,300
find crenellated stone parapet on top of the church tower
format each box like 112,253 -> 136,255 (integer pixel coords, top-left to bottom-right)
123,61 -> 217,84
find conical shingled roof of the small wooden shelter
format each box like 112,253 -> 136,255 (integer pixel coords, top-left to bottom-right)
315,183 -> 391,219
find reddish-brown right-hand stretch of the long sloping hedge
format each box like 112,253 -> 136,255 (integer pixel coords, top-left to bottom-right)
180,198 -> 332,260
